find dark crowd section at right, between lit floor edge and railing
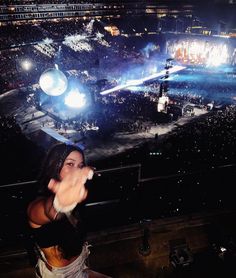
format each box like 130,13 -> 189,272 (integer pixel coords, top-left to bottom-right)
100,105 -> 236,176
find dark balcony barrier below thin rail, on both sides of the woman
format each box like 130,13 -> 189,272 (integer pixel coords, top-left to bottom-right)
0,164 -> 236,248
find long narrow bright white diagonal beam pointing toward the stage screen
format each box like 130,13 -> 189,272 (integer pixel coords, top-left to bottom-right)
100,66 -> 186,95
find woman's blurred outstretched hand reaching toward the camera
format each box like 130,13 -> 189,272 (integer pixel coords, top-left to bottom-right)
48,167 -> 94,207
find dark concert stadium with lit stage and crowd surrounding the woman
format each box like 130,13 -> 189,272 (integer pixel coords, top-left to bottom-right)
0,1 -> 236,277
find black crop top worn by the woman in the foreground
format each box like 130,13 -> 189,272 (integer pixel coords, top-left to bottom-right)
32,216 -> 85,259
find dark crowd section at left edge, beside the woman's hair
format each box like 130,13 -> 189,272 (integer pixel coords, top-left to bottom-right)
0,115 -> 43,185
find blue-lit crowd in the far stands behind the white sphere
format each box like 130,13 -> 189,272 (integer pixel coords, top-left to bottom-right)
0,19 -> 234,93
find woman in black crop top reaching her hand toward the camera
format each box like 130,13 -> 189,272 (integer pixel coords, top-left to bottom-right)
27,143 -> 111,278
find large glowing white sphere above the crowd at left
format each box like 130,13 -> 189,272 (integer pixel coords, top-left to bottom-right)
39,68 -> 68,96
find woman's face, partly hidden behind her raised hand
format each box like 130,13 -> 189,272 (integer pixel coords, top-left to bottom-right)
60,151 -> 84,179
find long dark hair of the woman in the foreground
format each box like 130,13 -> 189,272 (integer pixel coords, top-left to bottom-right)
38,143 -> 84,196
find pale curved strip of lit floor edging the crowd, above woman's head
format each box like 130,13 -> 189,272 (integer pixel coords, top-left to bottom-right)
0,89 -> 207,163
